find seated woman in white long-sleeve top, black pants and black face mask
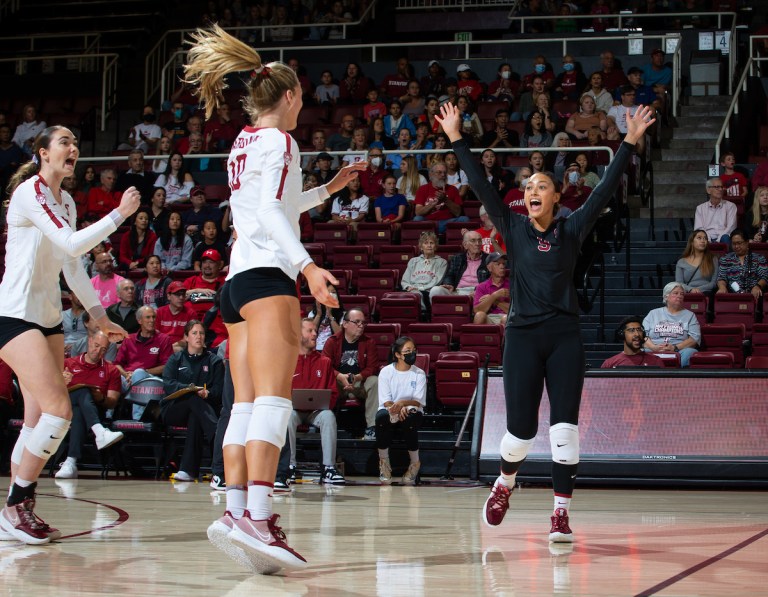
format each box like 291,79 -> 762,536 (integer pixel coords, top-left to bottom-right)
376,336 -> 427,485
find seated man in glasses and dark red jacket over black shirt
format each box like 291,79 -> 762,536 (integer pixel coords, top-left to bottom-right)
323,308 -> 379,440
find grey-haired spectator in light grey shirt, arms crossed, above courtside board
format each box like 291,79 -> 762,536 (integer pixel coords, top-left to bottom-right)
643,282 -> 701,367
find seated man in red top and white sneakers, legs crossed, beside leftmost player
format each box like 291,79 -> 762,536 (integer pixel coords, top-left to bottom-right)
55,331 -> 123,479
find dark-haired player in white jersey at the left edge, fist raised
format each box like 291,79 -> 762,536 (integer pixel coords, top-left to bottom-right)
0,126 -> 141,545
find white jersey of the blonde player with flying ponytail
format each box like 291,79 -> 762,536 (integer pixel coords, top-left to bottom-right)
227,126 -> 328,280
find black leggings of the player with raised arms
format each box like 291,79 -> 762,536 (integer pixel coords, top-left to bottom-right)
504,315 -> 585,439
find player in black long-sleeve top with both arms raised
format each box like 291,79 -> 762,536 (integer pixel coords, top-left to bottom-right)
440,104 -> 653,543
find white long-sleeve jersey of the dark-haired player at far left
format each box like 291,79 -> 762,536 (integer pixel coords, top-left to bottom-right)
0,175 -> 117,327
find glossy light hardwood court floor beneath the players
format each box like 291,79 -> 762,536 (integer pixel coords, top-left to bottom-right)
0,478 -> 768,597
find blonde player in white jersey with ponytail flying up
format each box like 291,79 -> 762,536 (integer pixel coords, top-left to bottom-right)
185,26 -> 367,574
